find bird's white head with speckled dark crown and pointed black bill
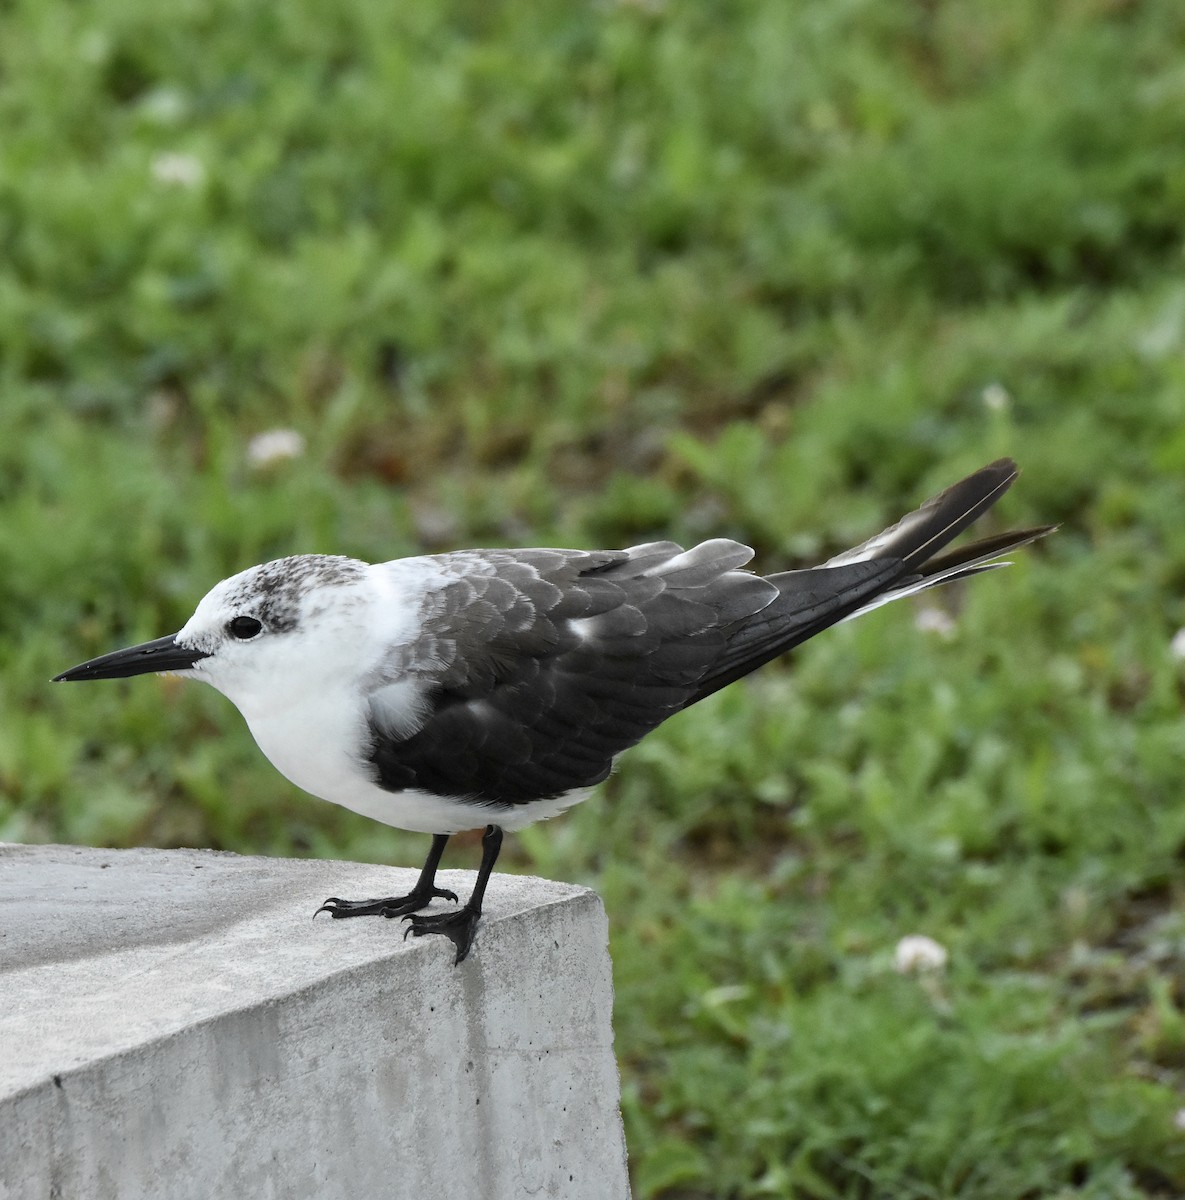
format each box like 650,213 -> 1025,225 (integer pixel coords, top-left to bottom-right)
54,554 -> 371,714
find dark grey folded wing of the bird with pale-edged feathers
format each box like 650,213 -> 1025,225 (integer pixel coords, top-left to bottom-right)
369,539 -> 901,805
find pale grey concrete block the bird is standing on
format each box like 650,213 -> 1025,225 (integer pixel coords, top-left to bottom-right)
0,845 -> 628,1200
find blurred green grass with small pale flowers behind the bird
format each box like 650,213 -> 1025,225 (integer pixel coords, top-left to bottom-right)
0,0 -> 1185,1200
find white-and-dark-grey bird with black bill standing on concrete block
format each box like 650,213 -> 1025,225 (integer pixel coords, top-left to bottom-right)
54,458 -> 1055,964
